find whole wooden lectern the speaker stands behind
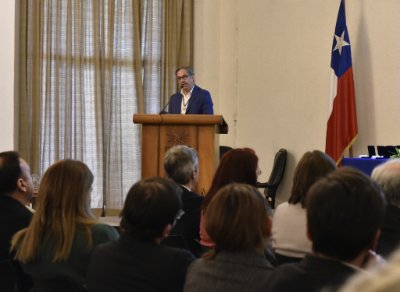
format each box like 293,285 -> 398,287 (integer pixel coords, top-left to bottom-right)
133,114 -> 228,196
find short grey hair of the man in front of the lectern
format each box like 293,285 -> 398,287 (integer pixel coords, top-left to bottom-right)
164,145 -> 199,185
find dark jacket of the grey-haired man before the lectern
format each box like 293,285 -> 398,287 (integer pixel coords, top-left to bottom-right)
170,186 -> 204,256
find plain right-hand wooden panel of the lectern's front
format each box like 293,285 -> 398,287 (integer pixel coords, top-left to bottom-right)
196,126 -> 215,196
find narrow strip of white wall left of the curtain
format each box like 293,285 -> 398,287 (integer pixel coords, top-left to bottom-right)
0,0 -> 18,152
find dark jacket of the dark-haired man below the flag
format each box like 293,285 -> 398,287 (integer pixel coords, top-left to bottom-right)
265,255 -> 356,292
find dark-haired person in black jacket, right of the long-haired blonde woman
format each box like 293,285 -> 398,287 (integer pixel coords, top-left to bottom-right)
87,177 -> 195,292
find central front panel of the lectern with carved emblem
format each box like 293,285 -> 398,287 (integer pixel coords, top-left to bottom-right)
158,125 -> 197,177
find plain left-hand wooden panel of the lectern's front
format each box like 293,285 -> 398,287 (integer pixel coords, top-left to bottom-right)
142,125 -> 160,179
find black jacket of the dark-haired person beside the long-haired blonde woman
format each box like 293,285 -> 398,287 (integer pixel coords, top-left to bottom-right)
86,232 -> 195,292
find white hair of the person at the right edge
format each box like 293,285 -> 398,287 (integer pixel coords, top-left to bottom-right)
371,159 -> 400,207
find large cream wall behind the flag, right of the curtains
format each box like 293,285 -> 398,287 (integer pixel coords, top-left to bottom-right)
194,0 -> 400,202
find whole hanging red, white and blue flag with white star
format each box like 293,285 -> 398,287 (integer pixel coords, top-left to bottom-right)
325,0 -> 358,165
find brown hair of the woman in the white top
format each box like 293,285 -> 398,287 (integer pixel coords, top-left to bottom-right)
288,150 -> 337,207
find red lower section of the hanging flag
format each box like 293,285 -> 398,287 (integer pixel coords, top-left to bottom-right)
325,67 -> 358,165
